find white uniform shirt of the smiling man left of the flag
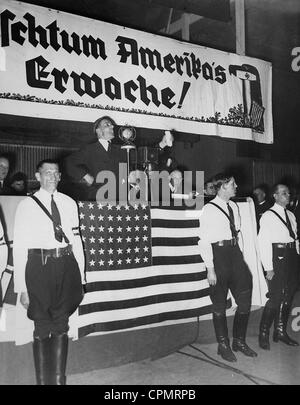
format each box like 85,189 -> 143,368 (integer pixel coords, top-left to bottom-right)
13,188 -> 85,292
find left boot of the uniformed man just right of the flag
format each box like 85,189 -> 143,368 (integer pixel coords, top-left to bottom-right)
213,313 -> 236,363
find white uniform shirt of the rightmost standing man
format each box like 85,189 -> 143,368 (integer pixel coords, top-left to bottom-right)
258,203 -> 298,271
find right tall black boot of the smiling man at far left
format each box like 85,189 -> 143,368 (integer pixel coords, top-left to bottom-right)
51,333 -> 69,385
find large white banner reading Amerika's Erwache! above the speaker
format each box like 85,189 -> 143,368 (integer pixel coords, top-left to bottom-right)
0,0 -> 273,143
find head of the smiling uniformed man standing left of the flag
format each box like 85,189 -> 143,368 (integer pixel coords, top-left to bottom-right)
35,159 -> 61,193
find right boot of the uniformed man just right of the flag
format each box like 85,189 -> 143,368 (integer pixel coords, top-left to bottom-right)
232,312 -> 257,357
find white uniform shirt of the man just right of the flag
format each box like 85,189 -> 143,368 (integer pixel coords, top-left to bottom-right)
198,196 -> 241,267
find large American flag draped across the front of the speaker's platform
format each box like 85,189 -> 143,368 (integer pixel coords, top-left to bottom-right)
78,201 -> 216,337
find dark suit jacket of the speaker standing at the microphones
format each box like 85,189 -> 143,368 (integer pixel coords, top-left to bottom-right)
64,141 -> 126,200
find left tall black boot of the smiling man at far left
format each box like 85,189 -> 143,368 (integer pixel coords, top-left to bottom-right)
32,337 -> 51,385
